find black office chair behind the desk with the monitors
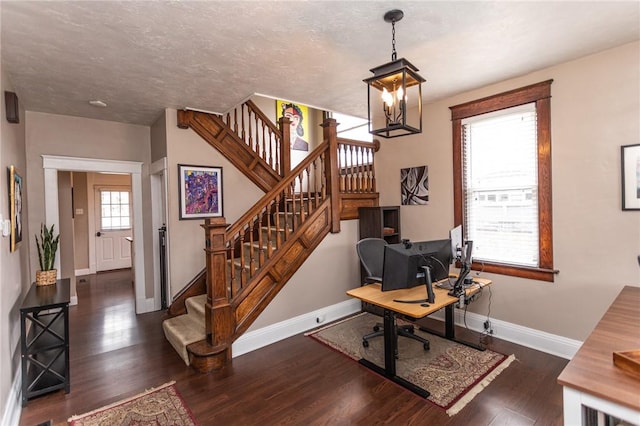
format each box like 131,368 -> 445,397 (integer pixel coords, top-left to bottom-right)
356,238 -> 429,357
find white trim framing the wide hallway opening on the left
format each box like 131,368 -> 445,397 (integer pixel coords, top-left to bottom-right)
42,155 -> 150,314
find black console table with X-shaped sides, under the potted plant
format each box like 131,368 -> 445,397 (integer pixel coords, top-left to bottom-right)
20,278 -> 70,406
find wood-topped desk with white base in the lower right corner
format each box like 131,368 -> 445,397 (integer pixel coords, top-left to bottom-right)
558,286 -> 640,425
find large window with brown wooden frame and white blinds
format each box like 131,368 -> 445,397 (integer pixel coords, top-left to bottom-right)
450,80 -> 556,281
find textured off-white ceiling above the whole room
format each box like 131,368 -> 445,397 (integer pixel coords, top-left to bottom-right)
0,0 -> 640,125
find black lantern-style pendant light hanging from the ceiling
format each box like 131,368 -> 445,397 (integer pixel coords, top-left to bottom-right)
363,9 -> 426,138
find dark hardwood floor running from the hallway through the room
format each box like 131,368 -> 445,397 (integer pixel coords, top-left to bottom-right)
20,270 -> 567,426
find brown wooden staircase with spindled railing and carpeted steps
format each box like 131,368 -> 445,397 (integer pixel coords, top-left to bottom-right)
163,102 -> 378,372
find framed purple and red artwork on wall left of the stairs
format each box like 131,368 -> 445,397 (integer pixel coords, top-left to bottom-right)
178,164 -> 223,220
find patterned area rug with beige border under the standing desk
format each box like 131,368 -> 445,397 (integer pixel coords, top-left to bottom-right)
307,312 -> 515,416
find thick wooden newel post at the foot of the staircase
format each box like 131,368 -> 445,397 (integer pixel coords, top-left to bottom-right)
203,217 -> 235,364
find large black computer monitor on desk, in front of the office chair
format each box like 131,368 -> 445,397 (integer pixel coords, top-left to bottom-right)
382,239 -> 452,303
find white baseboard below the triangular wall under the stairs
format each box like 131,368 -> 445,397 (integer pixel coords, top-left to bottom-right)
231,299 -> 361,358
